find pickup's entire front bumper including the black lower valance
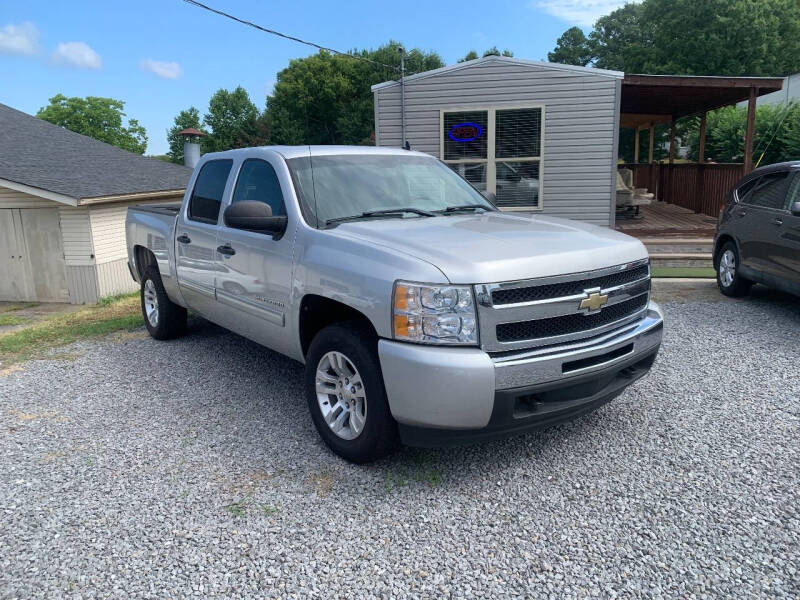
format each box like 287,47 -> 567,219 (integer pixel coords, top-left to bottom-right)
378,302 -> 663,446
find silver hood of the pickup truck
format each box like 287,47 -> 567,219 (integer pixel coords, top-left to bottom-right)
330,212 -> 647,284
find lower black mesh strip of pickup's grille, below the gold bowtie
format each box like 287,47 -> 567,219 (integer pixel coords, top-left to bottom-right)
497,294 -> 647,342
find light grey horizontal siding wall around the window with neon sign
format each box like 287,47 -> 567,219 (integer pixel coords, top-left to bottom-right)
375,61 -> 619,225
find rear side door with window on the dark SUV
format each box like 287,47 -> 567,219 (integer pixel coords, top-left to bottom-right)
737,171 -> 790,276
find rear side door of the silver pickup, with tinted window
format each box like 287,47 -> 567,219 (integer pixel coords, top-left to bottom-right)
175,159 -> 233,320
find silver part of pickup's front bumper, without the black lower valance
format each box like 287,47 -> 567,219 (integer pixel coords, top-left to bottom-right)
378,302 -> 663,429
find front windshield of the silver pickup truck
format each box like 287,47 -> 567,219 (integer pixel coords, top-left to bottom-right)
286,154 -> 494,226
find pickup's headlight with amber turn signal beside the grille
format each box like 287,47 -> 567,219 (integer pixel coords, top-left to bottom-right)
392,281 -> 478,344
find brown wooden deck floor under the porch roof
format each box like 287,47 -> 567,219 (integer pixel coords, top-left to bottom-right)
616,202 -> 717,239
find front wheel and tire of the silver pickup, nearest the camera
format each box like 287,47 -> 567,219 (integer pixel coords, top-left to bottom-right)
306,321 -> 398,464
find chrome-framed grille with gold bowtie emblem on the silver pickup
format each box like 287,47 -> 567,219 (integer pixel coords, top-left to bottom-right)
475,259 -> 650,352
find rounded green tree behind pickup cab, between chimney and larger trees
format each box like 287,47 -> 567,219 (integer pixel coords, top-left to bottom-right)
202,86 -> 263,152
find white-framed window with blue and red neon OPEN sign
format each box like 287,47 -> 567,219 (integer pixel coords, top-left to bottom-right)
441,106 -> 544,210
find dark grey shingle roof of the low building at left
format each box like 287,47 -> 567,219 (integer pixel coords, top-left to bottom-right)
0,104 -> 192,205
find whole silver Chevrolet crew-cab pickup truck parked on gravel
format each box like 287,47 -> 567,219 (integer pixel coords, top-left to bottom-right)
126,146 -> 663,462
